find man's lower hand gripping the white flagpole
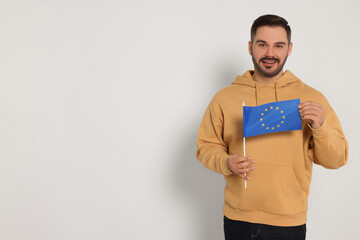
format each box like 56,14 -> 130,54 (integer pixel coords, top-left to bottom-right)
227,154 -> 255,180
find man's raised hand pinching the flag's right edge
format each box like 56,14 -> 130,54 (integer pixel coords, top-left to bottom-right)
298,101 -> 324,129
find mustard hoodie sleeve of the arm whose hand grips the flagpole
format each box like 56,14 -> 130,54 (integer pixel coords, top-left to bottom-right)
196,99 -> 232,175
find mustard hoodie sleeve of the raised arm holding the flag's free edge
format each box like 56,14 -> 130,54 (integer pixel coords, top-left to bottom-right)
308,101 -> 348,169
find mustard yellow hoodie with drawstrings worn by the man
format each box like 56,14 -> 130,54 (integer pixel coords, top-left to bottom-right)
196,71 -> 348,226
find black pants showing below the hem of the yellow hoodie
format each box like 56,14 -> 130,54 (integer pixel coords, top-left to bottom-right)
224,216 -> 306,240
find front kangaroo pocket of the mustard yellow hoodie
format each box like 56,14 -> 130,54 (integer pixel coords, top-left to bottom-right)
225,163 -> 307,215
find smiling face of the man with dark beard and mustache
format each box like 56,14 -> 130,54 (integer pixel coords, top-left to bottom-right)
249,26 -> 292,78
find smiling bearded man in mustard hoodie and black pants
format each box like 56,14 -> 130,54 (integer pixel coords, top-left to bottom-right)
196,15 -> 348,240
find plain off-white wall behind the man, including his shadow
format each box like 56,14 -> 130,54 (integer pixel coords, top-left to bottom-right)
0,0 -> 360,240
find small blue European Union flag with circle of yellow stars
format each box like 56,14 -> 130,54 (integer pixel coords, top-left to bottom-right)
243,99 -> 302,137
